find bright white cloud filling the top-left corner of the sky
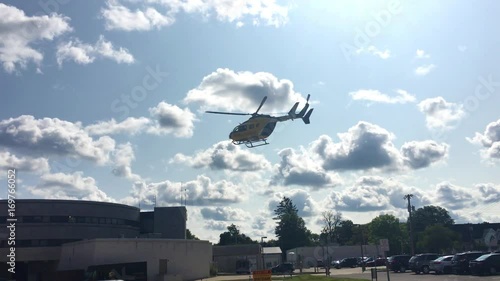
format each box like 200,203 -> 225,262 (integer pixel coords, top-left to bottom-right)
0,3 -> 72,73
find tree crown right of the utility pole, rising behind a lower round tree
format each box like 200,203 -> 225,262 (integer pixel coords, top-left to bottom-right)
412,205 -> 455,233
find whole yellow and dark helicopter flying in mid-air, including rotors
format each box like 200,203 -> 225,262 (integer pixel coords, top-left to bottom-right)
205,95 -> 313,148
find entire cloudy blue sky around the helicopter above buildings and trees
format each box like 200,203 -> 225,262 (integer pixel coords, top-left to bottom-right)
0,0 -> 500,242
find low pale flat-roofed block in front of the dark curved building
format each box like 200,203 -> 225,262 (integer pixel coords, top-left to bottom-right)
58,238 -> 212,281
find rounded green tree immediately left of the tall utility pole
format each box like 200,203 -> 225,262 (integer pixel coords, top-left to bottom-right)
369,214 -> 402,254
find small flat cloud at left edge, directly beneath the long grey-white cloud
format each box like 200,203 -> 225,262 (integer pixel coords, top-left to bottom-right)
0,151 -> 50,174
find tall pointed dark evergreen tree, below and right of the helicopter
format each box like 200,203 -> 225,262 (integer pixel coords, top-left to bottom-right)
273,197 -> 311,253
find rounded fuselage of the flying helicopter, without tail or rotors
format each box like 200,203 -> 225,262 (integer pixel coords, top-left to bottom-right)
229,115 -> 278,143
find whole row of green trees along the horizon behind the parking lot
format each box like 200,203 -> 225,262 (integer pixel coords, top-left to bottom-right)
188,197 -> 484,255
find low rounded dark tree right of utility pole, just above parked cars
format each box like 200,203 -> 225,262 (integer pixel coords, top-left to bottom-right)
417,224 -> 460,254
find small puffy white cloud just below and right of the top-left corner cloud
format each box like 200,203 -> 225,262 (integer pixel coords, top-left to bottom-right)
56,35 -> 134,66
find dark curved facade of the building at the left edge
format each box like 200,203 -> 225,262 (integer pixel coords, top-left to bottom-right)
0,199 -> 140,247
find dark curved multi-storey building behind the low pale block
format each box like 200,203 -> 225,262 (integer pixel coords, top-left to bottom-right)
0,199 -> 211,281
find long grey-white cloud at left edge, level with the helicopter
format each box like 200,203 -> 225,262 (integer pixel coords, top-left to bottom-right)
0,115 -> 115,164
